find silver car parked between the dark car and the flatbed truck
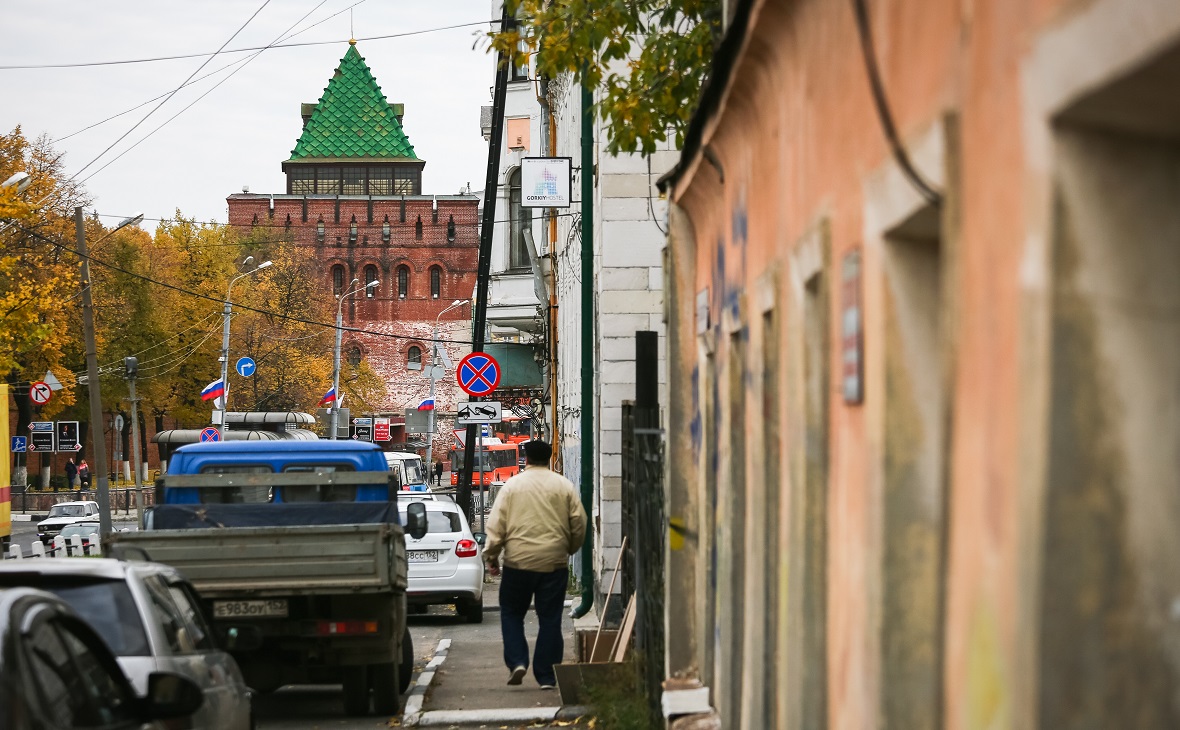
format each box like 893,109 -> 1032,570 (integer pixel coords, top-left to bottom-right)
0,558 -> 253,730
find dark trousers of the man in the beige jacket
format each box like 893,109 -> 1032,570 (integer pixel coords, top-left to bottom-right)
500,567 -> 568,685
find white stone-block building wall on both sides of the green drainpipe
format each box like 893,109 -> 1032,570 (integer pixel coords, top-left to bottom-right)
552,71 -> 677,592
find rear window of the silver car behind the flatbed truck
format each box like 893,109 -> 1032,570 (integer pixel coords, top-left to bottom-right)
0,573 -> 151,657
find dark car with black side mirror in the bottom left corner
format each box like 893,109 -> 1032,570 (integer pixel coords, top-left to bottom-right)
0,587 -> 204,730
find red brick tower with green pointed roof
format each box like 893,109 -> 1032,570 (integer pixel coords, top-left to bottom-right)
228,41 -> 479,456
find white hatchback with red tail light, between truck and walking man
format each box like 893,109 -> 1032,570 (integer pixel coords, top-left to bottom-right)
398,495 -> 484,624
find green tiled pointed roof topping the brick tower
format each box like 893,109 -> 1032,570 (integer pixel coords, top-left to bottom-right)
290,46 -> 418,160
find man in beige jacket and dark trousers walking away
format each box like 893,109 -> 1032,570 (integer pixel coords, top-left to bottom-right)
484,440 -> 586,690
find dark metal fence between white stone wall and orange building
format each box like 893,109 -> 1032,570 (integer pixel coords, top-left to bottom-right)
622,401 -> 667,717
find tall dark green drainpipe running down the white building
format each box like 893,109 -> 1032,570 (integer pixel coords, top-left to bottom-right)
571,72 -> 595,618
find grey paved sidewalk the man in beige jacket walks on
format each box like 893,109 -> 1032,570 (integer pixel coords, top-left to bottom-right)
402,579 -> 597,728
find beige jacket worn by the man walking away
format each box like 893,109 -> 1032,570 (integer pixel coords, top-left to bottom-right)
484,465 -> 586,573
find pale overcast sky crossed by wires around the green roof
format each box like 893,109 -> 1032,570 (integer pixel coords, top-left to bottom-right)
0,0 -> 494,230
